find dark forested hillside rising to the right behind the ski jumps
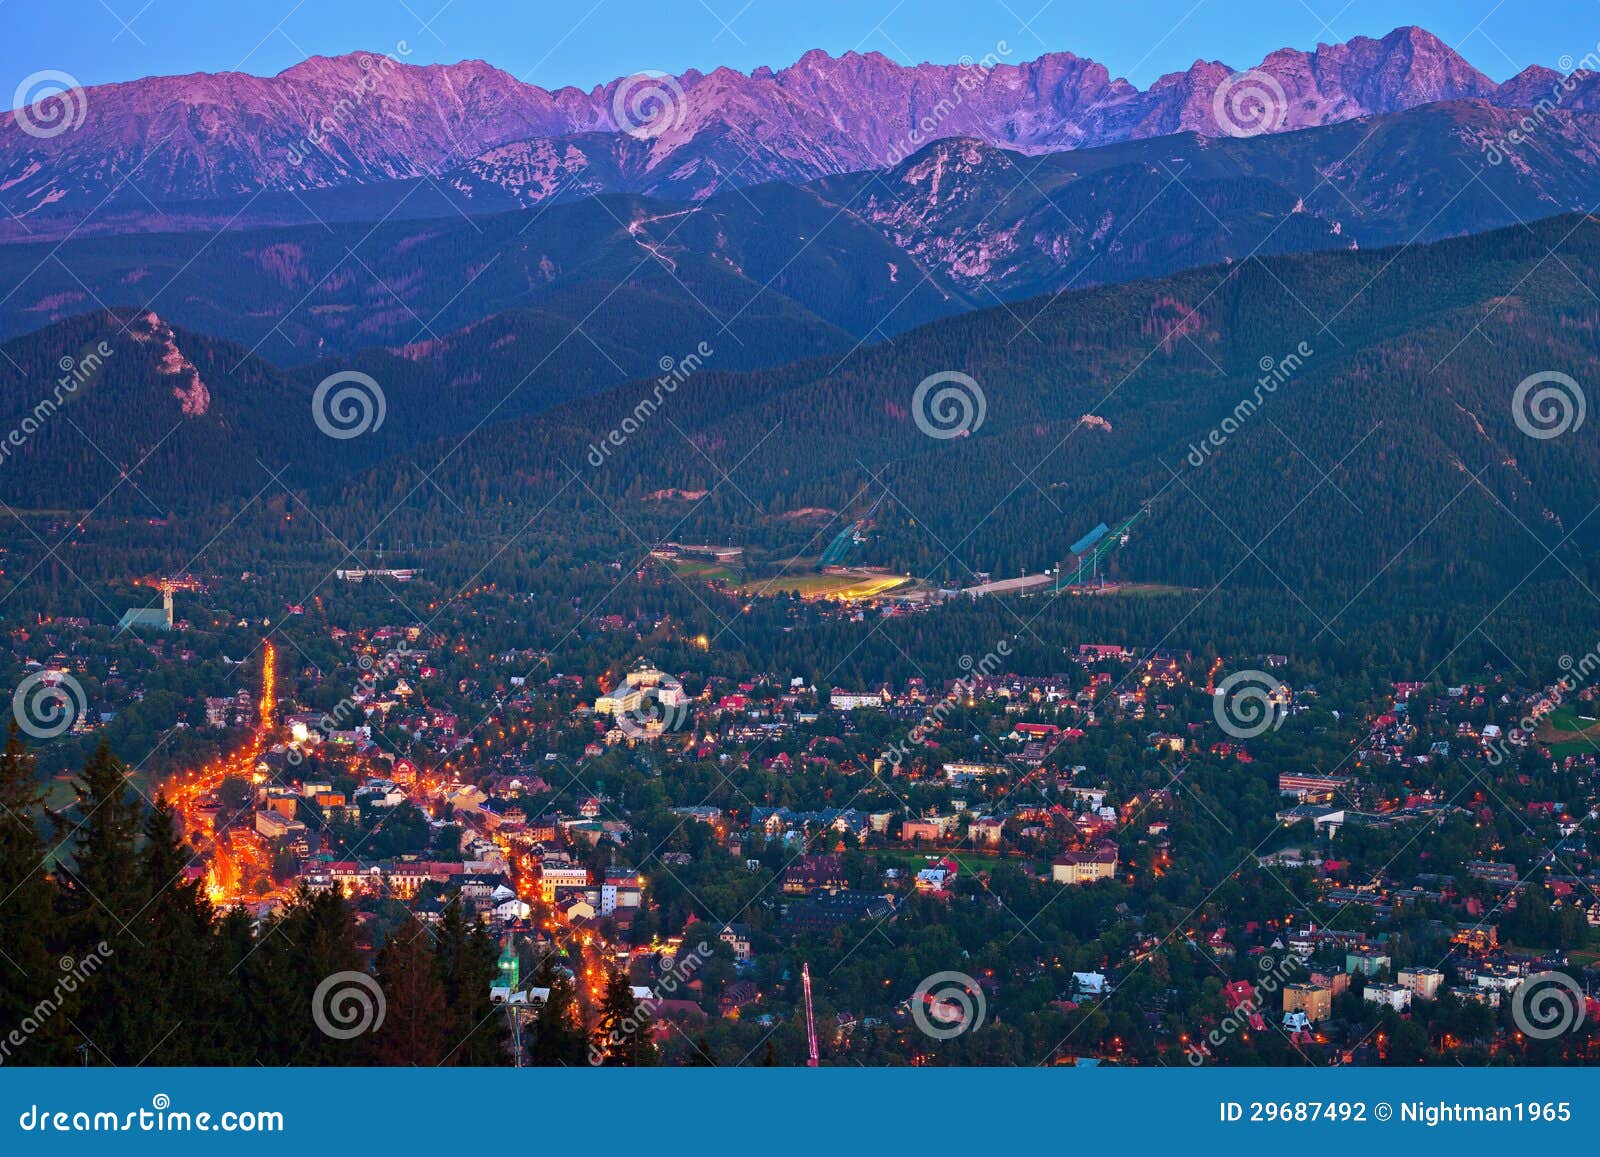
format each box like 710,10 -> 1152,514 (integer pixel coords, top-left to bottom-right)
312,218 -> 1600,614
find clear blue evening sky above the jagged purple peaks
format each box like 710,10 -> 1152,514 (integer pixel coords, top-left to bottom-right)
0,0 -> 1600,96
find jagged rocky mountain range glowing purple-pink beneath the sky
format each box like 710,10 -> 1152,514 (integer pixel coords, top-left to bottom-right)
0,27 -> 1600,227
